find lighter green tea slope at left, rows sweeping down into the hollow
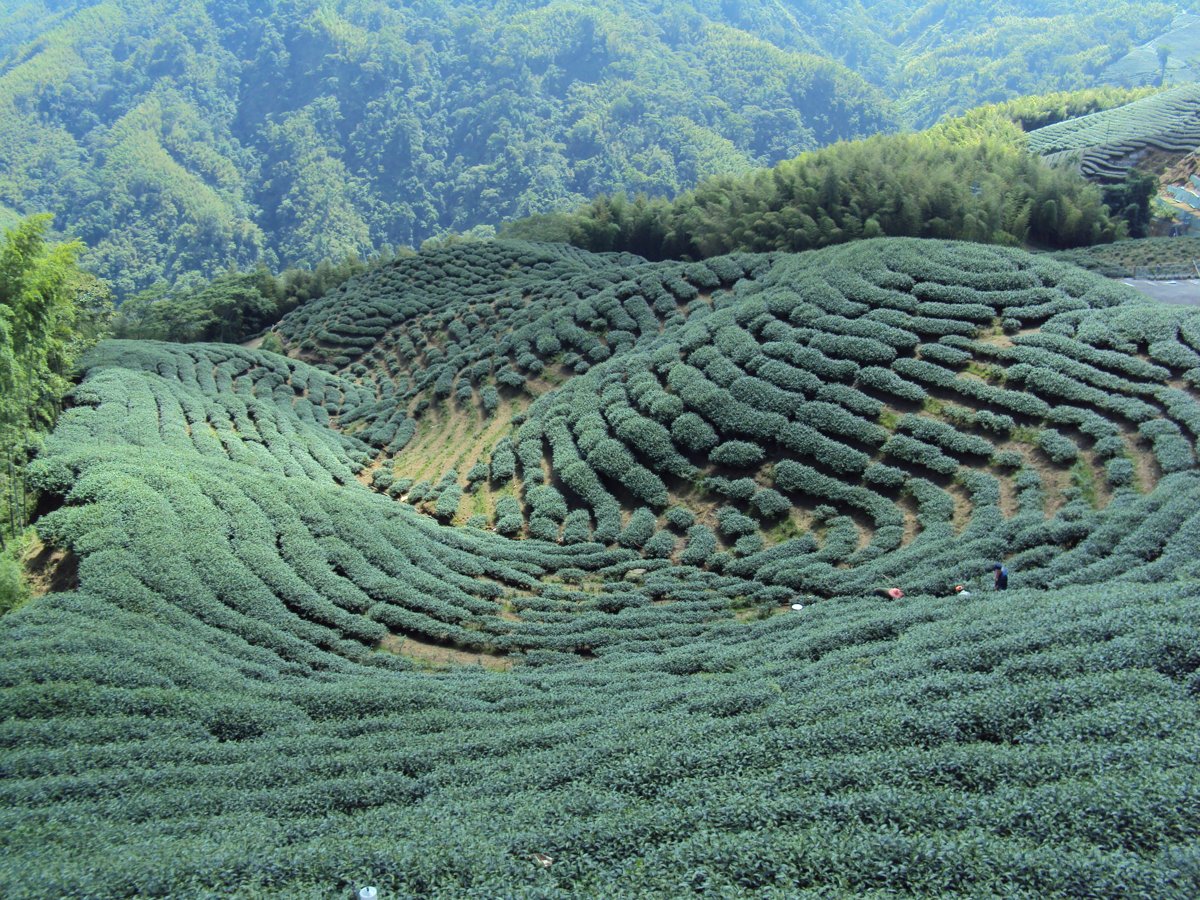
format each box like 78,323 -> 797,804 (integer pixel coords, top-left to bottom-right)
38,341 -> 739,673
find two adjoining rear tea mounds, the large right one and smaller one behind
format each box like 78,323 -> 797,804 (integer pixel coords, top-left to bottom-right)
280,241 -> 1200,596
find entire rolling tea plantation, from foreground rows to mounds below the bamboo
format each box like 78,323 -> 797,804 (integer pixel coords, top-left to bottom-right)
0,240 -> 1200,898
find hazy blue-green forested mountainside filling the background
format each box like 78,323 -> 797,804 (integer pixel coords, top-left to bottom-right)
0,0 -> 1174,294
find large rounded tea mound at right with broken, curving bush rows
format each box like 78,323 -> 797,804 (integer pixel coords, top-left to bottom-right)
412,241 -> 1200,593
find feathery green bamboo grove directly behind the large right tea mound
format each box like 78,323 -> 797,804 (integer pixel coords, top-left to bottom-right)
503,102 -> 1137,259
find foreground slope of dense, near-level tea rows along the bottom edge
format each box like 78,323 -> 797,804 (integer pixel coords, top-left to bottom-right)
0,571 -> 1200,898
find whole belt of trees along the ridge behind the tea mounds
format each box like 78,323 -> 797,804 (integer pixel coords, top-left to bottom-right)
96,88 -> 1165,342
